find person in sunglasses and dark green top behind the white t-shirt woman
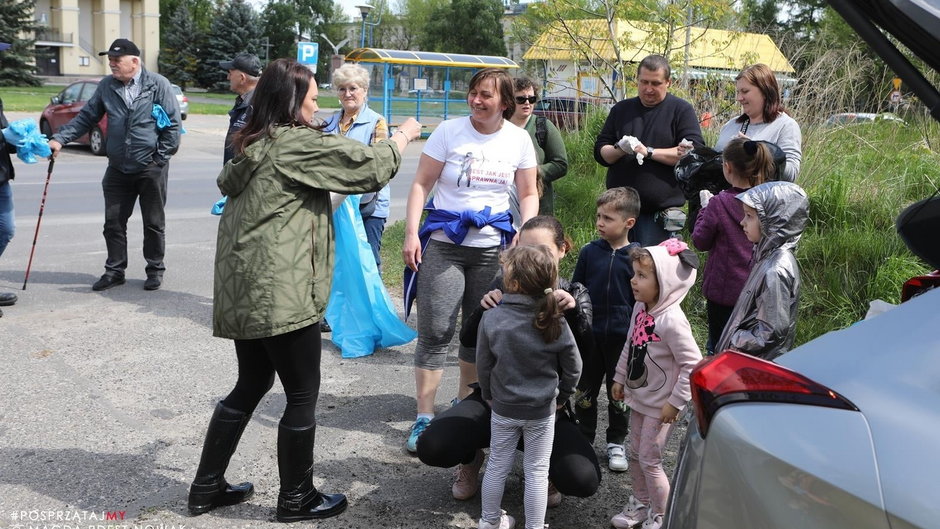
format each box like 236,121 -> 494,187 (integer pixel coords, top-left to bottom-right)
509,77 -> 568,215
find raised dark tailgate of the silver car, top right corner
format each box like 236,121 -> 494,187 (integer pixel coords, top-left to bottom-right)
829,0 -> 940,121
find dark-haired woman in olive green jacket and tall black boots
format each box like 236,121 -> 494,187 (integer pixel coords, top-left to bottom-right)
189,59 -> 421,522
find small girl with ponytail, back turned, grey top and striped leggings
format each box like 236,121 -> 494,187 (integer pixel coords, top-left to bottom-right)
476,246 -> 581,529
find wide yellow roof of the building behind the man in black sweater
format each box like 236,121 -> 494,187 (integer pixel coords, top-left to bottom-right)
523,19 -> 795,73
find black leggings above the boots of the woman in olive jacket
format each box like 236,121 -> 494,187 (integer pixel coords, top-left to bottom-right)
222,324 -> 321,428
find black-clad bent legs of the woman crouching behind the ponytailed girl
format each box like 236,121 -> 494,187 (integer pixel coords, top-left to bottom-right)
418,389 -> 601,498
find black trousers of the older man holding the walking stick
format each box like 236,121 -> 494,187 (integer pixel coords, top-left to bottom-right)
101,162 -> 170,277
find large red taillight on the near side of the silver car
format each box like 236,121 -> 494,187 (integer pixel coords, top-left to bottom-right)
689,351 -> 858,437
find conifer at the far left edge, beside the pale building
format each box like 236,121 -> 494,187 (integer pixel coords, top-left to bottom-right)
0,0 -> 42,86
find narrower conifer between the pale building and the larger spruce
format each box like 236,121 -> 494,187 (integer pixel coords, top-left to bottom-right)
157,2 -> 205,90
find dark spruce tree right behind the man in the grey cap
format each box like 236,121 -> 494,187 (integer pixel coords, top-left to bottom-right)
196,0 -> 262,92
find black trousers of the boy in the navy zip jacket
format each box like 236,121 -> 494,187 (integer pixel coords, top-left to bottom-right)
574,334 -> 630,445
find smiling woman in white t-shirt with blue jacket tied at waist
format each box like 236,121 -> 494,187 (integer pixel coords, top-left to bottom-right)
402,68 -> 539,452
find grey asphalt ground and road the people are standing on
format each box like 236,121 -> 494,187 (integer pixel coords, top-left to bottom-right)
0,113 -> 674,529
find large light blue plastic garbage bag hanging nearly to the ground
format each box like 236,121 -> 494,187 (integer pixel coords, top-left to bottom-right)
326,195 -> 417,358
